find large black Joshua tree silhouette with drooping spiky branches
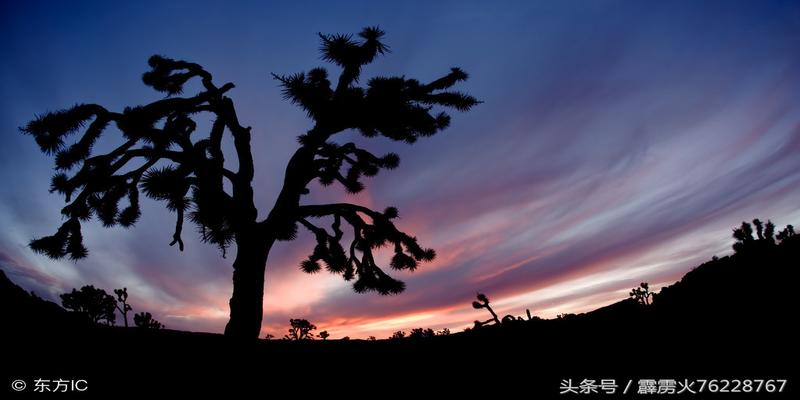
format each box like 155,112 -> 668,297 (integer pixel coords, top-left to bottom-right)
21,27 -> 478,340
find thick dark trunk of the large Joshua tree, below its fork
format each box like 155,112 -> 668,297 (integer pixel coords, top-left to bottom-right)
225,234 -> 275,340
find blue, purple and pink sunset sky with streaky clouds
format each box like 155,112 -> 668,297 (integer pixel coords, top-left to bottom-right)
0,0 -> 800,338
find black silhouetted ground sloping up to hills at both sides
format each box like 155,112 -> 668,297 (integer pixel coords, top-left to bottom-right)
0,236 -> 800,398
